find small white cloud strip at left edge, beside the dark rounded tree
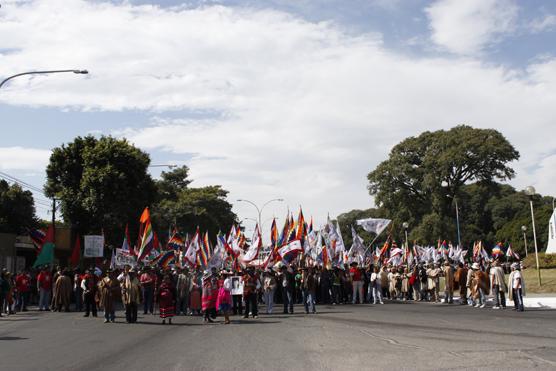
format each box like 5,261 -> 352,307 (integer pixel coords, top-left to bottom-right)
0,147 -> 50,172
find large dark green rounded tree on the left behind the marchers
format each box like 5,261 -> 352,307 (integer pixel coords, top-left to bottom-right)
45,136 -> 156,244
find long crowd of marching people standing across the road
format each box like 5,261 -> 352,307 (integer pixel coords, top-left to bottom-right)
0,260 -> 525,324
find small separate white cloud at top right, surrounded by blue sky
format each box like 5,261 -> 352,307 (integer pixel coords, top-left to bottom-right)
425,0 -> 518,55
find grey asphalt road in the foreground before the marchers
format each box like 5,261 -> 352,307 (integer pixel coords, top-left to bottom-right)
0,302 -> 556,371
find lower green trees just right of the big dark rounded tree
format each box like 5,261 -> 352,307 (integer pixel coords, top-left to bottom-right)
153,166 -> 237,242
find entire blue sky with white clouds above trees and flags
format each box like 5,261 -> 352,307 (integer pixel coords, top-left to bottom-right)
0,0 -> 556,237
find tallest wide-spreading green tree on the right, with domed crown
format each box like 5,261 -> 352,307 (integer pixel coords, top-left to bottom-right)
368,125 -> 519,248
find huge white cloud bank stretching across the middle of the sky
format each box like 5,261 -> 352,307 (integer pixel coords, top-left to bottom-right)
0,0 -> 556,228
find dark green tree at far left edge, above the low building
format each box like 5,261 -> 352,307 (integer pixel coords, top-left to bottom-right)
0,180 -> 38,234
